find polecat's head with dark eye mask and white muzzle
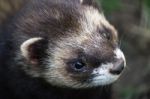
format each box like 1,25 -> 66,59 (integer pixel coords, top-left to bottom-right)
16,0 -> 125,88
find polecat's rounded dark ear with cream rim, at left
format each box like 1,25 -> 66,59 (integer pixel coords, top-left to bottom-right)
20,37 -> 48,65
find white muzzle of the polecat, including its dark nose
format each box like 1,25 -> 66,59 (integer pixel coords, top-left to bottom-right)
86,49 -> 126,86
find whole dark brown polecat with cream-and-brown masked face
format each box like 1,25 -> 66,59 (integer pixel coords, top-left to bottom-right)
0,0 -> 125,99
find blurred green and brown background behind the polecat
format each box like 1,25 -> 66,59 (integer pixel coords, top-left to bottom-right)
0,0 -> 150,99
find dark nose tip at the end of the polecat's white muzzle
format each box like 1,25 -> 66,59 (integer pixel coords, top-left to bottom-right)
110,59 -> 124,75
